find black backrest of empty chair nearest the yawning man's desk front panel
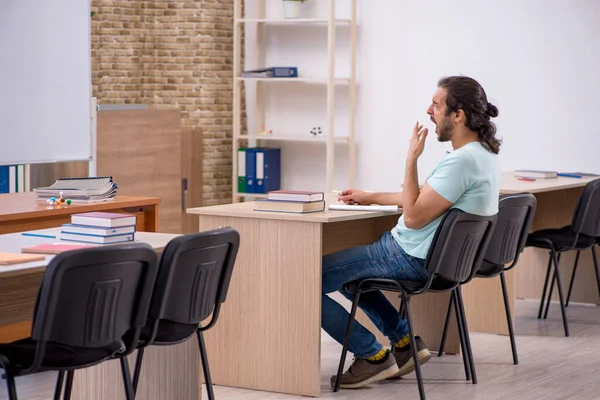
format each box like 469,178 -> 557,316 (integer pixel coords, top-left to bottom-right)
148,227 -> 240,334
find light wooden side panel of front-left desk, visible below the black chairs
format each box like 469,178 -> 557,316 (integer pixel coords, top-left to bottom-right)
72,335 -> 202,400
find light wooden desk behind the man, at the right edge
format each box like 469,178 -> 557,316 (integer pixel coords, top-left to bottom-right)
463,172 -> 600,335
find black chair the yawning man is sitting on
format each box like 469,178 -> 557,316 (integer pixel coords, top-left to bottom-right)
334,208 -> 497,399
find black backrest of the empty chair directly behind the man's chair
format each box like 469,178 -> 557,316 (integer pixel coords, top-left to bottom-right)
483,193 -> 537,268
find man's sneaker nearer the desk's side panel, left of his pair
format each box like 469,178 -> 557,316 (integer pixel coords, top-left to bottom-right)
331,351 -> 398,389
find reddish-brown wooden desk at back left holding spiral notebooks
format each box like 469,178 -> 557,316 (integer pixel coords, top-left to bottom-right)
0,192 -> 160,234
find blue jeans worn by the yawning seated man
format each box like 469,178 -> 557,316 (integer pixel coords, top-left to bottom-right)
321,232 -> 429,358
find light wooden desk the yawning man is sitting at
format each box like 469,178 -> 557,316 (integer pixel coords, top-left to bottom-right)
188,198 -> 459,397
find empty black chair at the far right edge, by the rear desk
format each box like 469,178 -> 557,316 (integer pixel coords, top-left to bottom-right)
526,179 -> 600,336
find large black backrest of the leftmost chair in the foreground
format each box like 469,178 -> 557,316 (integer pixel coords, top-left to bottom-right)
31,243 -> 158,363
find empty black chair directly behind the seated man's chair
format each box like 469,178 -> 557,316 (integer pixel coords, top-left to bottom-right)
438,194 -> 537,364
